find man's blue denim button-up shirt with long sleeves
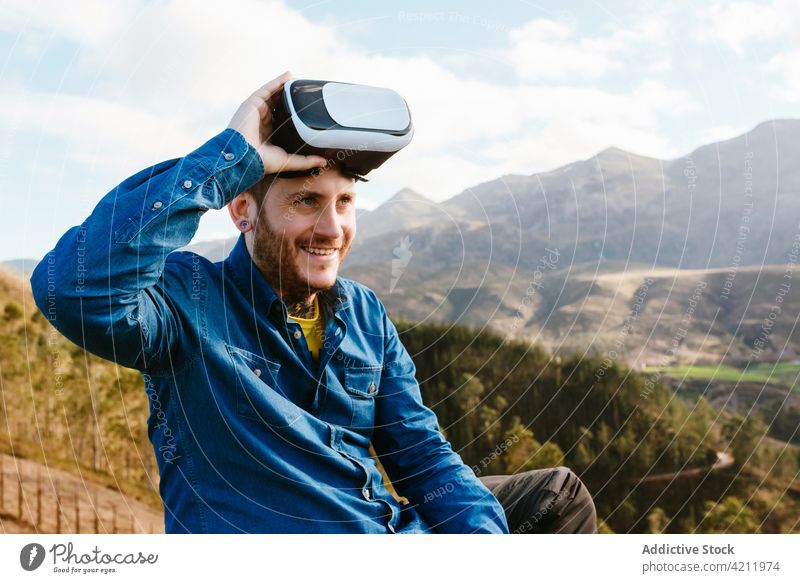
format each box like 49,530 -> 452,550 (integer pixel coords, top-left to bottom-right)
31,129 -> 508,533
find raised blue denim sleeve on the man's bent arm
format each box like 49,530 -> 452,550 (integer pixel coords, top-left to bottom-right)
31,129 -> 264,368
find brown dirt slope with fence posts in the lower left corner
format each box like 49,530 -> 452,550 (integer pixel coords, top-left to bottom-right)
0,453 -> 164,534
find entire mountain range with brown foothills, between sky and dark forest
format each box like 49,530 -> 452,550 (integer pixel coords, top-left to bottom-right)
178,119 -> 800,364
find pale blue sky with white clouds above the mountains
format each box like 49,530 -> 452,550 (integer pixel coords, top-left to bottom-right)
0,0 -> 800,261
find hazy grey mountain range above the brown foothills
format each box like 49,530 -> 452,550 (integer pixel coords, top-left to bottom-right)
352,120 -> 800,269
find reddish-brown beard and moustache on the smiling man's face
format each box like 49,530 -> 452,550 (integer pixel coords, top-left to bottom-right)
253,212 -> 350,300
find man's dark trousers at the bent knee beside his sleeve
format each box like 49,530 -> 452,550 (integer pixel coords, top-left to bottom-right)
480,466 -> 597,534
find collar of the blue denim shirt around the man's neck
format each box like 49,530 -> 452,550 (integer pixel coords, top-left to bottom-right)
223,233 -> 350,320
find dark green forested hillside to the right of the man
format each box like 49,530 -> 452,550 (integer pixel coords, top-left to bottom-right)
398,322 -> 800,533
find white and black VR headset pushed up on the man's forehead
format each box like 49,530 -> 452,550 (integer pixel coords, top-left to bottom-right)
270,79 -> 414,182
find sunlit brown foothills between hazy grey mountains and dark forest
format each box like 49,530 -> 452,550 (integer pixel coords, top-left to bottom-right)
348,257 -> 800,368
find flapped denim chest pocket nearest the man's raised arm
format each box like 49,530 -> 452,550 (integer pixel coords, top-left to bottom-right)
225,344 -> 303,428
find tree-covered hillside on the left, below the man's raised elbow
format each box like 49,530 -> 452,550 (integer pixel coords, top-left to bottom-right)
0,271 -> 161,508
